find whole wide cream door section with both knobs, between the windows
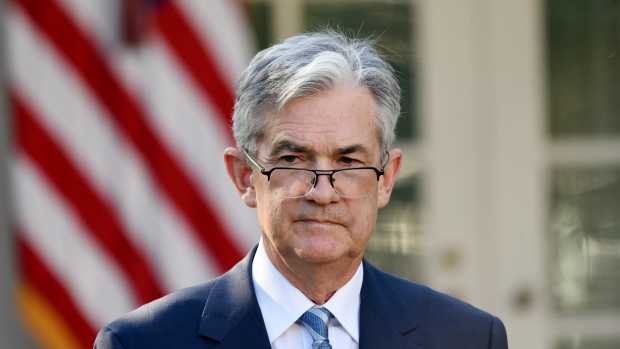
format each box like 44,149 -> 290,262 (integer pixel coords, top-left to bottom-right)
415,0 -> 549,349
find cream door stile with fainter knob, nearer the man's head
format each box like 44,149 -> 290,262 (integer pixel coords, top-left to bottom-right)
416,0 -> 492,306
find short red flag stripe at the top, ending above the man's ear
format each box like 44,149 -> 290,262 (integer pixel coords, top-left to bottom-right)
155,1 -> 234,136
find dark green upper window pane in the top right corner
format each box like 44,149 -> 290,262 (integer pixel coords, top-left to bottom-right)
546,0 -> 620,137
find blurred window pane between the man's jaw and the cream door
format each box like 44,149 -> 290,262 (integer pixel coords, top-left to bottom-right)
366,175 -> 424,281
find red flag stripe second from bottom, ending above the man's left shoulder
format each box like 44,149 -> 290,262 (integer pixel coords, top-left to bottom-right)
10,93 -> 163,302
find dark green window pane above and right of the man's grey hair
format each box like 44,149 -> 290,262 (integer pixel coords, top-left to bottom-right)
304,0 -> 416,141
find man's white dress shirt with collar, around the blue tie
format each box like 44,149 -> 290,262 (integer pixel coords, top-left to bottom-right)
252,239 -> 364,349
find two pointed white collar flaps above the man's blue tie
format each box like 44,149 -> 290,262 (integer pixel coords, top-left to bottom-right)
252,239 -> 364,343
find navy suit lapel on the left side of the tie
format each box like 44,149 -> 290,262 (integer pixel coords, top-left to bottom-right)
198,247 -> 271,349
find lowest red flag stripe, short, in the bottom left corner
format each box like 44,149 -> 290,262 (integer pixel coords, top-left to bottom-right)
16,232 -> 96,348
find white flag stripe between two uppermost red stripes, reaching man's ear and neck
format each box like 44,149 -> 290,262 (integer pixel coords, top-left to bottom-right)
138,41 -> 259,251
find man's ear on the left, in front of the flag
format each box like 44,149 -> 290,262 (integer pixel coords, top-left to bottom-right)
224,147 -> 256,207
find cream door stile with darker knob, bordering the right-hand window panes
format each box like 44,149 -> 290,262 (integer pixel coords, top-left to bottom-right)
486,0 -> 553,349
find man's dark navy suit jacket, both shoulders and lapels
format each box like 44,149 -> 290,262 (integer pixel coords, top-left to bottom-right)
94,249 -> 508,349
